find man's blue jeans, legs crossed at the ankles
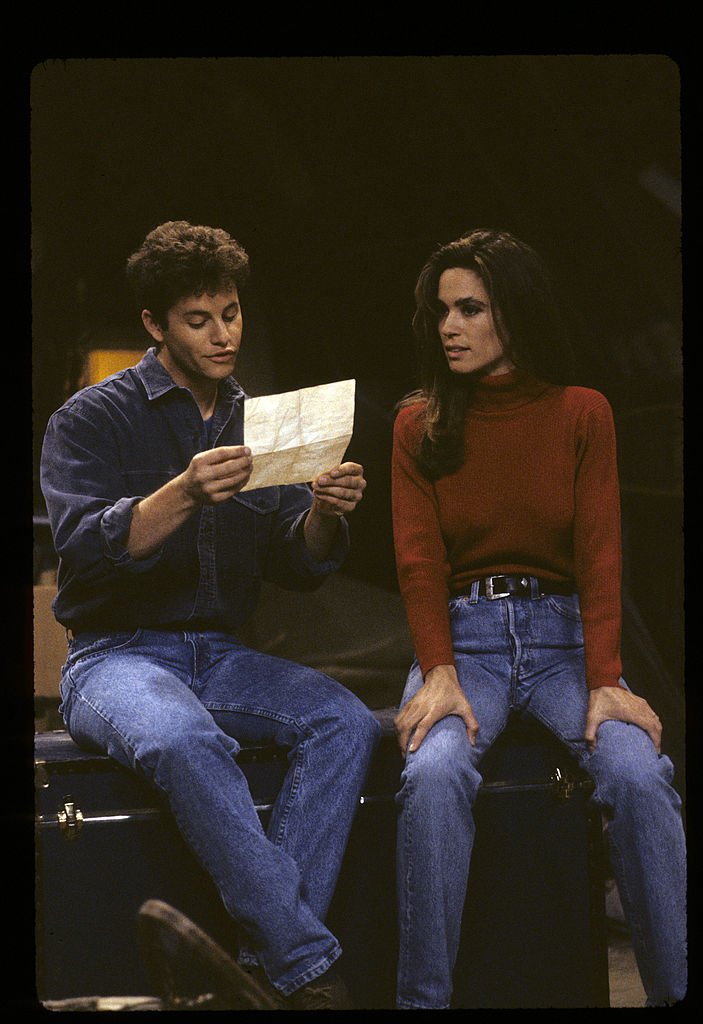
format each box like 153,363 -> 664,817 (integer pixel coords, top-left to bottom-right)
61,630 -> 381,995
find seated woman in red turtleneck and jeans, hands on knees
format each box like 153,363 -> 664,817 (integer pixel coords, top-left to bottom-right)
393,230 -> 686,1009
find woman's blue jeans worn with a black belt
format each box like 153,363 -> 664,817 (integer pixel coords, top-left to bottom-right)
397,593 -> 687,1009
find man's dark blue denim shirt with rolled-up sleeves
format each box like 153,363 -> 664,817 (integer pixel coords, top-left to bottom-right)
41,349 -> 349,633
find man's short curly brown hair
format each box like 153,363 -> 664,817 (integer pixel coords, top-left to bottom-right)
127,220 -> 249,327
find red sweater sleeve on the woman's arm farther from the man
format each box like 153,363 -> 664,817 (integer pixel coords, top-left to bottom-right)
574,392 -> 622,689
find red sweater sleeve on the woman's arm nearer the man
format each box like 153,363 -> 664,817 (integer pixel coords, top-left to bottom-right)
392,404 -> 454,675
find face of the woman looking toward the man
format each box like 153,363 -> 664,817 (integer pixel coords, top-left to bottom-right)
437,266 -> 515,376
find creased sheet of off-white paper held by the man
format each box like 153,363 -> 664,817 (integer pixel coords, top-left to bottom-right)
241,380 -> 356,490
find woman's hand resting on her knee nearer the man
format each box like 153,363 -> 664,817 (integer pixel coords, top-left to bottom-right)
395,665 -> 479,755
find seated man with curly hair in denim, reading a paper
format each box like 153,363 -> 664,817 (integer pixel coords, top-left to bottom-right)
42,221 -> 380,1010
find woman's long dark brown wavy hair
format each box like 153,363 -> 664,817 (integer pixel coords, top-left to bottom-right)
400,229 -> 573,480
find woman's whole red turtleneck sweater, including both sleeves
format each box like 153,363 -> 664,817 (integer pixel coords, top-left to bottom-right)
393,371 -> 621,689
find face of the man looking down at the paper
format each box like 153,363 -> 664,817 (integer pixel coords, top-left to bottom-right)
141,288 -> 241,388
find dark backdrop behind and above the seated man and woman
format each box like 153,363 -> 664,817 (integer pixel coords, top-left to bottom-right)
31,54 -> 684,755
